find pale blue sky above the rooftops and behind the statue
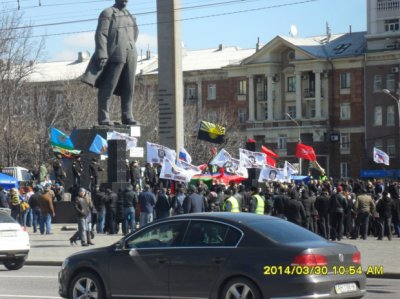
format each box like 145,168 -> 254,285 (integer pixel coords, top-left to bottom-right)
0,0 -> 368,61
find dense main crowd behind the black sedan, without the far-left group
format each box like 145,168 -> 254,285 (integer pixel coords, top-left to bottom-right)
62,173 -> 400,246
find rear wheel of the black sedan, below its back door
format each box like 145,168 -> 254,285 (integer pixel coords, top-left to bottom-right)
222,277 -> 262,299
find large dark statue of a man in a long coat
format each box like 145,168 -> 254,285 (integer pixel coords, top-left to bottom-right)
82,0 -> 139,125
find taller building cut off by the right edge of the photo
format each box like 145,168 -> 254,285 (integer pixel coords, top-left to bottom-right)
362,0 -> 400,178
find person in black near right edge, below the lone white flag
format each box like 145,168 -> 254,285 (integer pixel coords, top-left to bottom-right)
376,191 -> 395,241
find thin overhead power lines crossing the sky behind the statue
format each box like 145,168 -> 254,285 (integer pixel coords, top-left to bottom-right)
0,0 -> 320,34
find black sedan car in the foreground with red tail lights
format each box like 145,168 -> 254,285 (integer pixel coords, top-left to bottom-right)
59,213 -> 365,299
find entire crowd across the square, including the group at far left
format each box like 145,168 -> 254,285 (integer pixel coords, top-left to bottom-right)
0,157 -> 400,246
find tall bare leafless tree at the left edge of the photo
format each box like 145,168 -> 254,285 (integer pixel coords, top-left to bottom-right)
0,11 -> 44,169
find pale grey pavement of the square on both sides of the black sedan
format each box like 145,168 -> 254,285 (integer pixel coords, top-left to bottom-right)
26,224 -> 400,279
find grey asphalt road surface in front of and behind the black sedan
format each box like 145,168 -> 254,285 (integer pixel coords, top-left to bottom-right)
0,266 -> 400,299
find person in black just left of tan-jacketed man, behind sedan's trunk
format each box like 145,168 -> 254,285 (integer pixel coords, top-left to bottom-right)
329,185 -> 347,241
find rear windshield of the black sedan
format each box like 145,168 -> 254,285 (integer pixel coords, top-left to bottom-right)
247,220 -> 325,244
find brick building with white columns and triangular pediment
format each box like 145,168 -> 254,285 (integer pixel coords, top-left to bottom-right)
225,30 -> 365,177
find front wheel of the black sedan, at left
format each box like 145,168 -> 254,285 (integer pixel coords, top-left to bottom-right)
69,272 -> 105,299
